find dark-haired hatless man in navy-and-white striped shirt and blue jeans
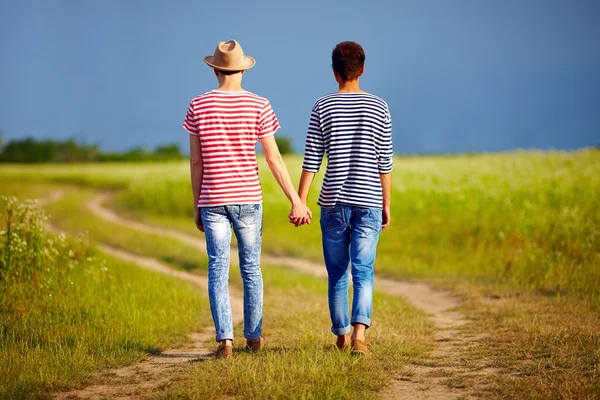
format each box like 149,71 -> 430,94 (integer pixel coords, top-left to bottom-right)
290,42 -> 393,356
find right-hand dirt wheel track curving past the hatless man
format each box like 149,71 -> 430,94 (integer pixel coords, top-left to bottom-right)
86,193 -> 497,399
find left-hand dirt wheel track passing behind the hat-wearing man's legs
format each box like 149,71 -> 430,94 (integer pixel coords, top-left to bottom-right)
38,191 -> 244,400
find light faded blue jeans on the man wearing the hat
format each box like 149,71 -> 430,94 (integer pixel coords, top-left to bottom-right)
200,204 -> 263,341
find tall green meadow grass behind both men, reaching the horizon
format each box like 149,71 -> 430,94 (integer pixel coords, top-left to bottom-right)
0,149 -> 600,300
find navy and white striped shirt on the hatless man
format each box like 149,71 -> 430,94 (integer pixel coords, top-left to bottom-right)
302,93 -> 393,208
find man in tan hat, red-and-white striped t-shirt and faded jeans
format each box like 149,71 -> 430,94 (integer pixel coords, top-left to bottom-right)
183,40 -> 312,358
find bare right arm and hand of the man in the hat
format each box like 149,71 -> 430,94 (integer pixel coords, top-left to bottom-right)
260,135 -> 312,226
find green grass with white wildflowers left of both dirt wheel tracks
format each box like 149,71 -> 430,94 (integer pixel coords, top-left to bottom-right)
0,197 -> 209,398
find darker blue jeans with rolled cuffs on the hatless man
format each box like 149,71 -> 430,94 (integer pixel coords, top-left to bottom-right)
321,204 -> 382,335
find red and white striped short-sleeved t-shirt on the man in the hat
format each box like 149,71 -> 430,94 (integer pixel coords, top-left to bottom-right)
183,90 -> 279,207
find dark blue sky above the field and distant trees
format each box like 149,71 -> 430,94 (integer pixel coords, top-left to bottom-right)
0,0 -> 600,153
